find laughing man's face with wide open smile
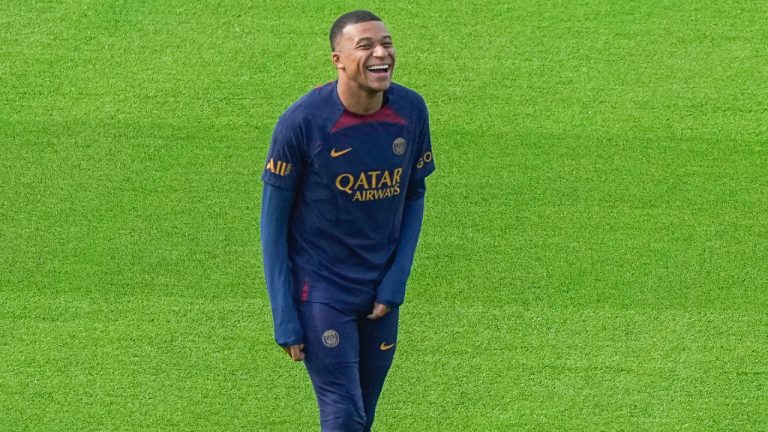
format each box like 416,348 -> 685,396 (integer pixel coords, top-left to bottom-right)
333,21 -> 395,92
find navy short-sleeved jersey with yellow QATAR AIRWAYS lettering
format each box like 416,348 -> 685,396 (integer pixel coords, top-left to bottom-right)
262,82 -> 435,310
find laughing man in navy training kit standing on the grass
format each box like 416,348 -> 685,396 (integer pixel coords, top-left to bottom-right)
261,11 -> 434,432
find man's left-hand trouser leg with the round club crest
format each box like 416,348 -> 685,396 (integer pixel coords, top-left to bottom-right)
298,303 -> 365,432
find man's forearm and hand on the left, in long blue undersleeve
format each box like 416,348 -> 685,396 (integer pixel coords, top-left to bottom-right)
261,184 -> 304,360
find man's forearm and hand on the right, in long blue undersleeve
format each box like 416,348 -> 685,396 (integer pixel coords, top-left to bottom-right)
368,180 -> 426,319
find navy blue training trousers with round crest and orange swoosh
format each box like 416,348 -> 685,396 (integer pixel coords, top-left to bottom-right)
298,303 -> 399,432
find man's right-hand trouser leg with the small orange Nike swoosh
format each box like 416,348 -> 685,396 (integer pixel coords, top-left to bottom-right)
359,308 -> 400,431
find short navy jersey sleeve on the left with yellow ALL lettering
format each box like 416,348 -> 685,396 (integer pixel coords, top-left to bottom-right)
261,115 -> 306,190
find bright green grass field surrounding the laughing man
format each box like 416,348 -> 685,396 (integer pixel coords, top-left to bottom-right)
0,0 -> 768,432
